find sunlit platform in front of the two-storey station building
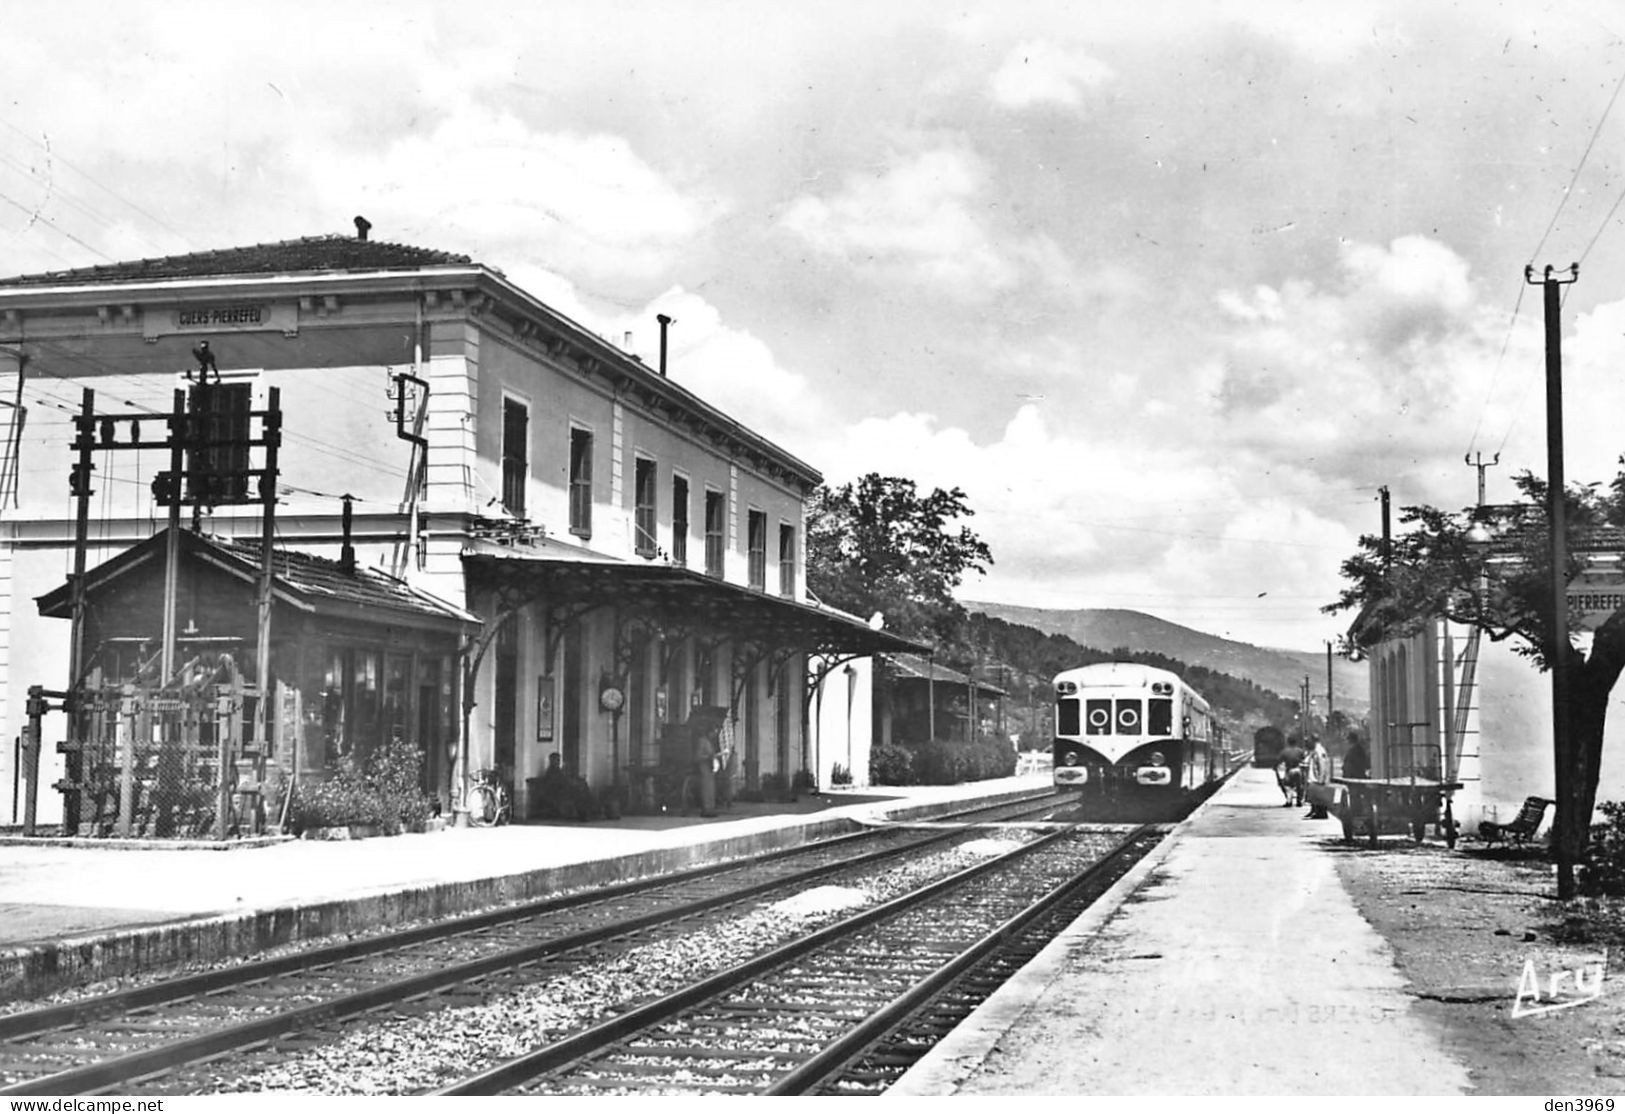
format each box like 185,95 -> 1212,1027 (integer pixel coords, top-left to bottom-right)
0,771 -> 1050,1002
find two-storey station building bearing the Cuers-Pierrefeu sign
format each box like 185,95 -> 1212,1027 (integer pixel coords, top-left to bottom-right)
0,219 -> 921,820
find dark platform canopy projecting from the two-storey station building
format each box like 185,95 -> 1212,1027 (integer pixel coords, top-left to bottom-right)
463,551 -> 931,658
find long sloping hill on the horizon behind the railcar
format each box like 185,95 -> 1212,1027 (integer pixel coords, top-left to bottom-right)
965,601 -> 1372,718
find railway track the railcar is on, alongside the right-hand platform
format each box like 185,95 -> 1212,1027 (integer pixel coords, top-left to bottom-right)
436,825 -> 1162,1096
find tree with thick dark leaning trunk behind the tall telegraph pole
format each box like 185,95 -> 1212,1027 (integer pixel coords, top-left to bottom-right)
1323,471 -> 1625,900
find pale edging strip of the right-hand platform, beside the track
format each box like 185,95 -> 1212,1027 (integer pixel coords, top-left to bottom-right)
879,773 -> 1235,1099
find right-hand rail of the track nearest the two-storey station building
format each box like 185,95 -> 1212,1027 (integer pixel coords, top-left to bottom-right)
0,794 -> 1060,1096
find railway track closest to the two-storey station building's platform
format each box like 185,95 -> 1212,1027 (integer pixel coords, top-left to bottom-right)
0,794 -> 1055,1095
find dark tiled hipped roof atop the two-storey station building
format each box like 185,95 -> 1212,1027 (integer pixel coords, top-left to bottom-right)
0,235 -> 473,287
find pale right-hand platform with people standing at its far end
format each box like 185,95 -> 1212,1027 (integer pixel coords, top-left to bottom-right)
884,768 -> 1467,1098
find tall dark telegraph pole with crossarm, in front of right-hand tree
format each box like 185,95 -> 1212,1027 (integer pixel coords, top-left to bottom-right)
1524,263 -> 1591,901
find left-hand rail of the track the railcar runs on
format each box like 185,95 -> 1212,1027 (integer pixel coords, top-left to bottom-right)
429,825 -> 1105,1096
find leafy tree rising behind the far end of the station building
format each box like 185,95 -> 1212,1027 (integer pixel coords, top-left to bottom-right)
808,473 -> 993,640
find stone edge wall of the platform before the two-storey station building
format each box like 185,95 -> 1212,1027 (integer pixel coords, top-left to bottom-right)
0,791 -> 1030,1004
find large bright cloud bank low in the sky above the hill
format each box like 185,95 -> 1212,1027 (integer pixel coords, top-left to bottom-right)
812,396 -> 1355,645
